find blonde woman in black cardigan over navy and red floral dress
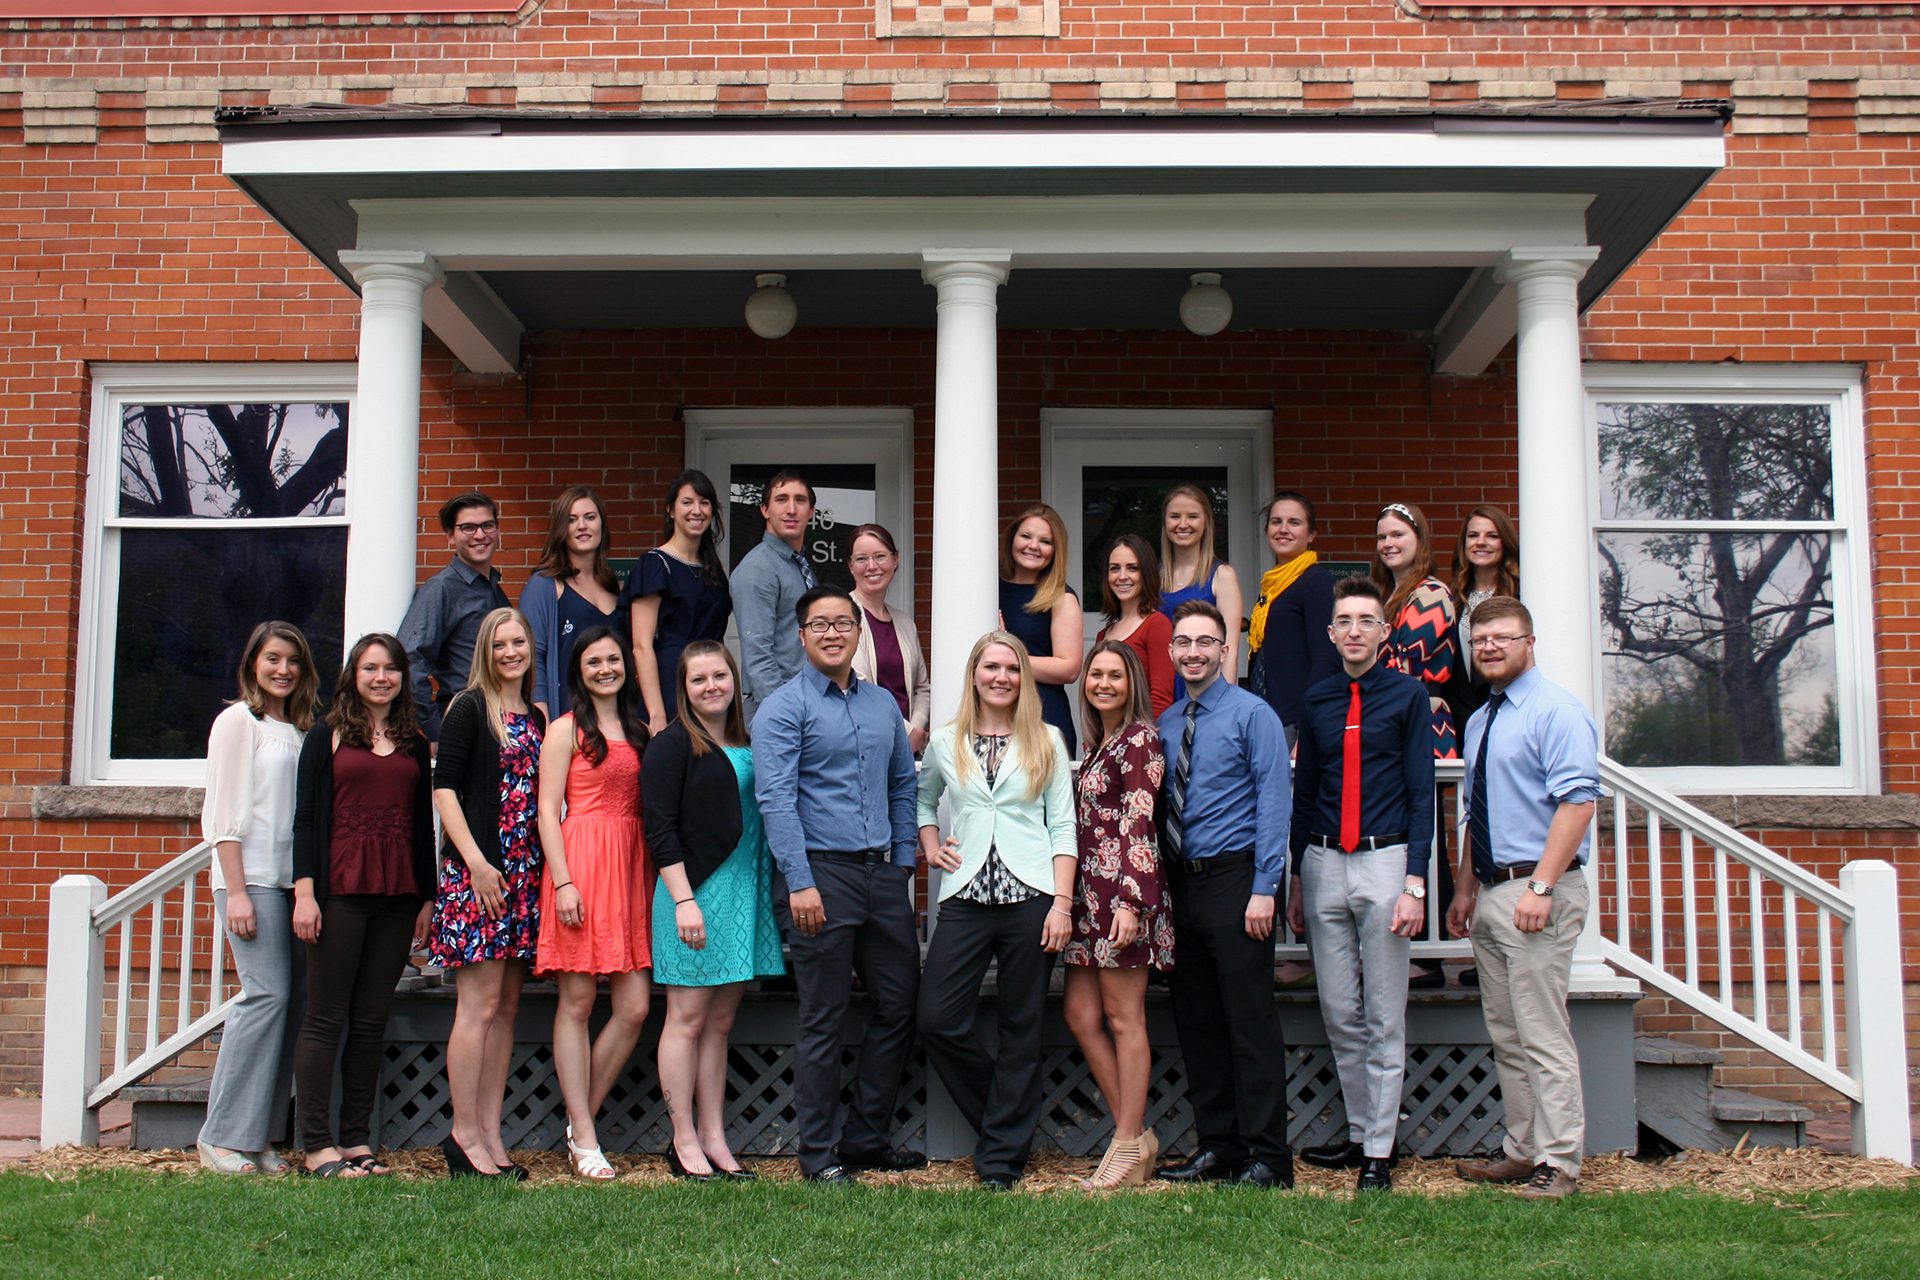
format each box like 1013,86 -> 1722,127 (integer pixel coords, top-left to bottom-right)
428,608 -> 547,1180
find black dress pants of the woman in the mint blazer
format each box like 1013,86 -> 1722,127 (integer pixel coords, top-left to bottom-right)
920,894 -> 1054,1178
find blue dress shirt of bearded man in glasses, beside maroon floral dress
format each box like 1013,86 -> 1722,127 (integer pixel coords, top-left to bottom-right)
1160,679 -> 1294,894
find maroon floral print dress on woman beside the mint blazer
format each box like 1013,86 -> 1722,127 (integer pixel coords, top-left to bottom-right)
1064,723 -> 1173,969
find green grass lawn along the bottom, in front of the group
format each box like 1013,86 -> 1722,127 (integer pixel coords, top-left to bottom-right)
0,1171 -> 1920,1280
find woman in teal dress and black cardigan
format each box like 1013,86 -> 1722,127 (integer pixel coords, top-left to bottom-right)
639,641 -> 785,1180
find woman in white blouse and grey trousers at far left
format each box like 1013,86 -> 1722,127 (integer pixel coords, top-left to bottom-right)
198,622 -> 319,1173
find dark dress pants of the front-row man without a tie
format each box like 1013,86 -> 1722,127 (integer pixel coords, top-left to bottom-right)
774,858 -> 920,1173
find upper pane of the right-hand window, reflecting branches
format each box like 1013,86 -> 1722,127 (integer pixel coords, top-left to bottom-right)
1597,403 -> 1834,520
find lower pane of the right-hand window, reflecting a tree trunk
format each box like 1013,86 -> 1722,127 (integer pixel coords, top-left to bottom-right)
1599,532 -> 1839,766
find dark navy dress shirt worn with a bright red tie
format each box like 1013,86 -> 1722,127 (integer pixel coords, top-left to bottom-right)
1292,662 -> 1434,875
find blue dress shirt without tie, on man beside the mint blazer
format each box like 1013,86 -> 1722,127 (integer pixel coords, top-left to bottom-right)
753,666 -> 920,892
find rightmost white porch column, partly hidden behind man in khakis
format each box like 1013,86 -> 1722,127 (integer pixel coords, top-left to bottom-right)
1498,246 -> 1636,992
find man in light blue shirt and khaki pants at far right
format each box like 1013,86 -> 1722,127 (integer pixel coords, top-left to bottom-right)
1448,595 -> 1599,1199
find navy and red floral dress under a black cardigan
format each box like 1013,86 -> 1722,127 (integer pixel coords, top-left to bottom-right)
428,712 -> 545,969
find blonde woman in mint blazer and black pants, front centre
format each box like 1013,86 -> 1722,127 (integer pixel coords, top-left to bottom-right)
920,631 -> 1079,1190
